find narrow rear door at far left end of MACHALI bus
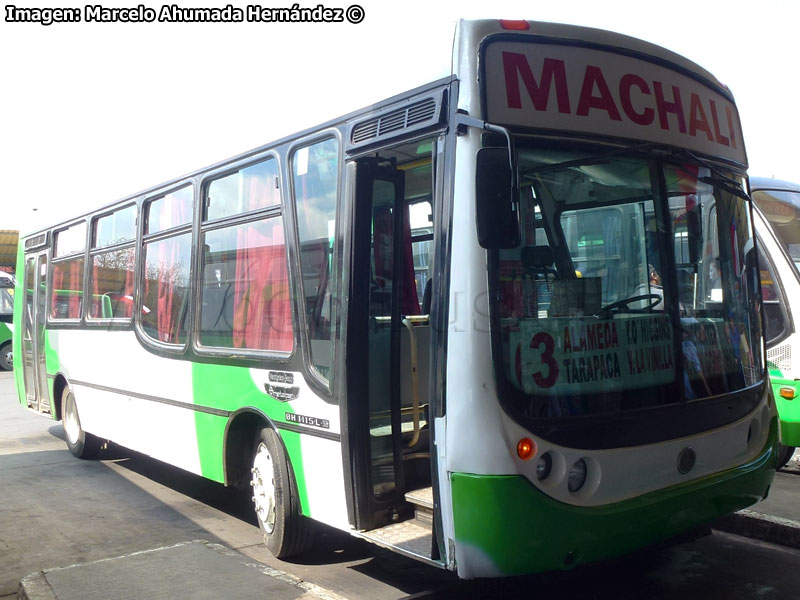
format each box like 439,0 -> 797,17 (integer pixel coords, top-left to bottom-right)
22,252 -> 51,412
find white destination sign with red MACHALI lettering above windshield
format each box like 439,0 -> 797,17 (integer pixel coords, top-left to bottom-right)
484,41 -> 747,165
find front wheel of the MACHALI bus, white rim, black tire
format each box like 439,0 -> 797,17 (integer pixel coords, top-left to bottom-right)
251,427 -> 314,558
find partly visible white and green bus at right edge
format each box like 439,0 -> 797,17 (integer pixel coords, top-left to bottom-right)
750,177 -> 800,466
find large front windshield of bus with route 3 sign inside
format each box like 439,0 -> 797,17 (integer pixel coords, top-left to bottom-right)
490,145 -> 763,418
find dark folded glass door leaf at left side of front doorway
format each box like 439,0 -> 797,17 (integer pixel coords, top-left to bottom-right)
347,158 -> 413,529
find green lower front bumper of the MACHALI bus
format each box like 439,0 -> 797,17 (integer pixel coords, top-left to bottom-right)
451,420 -> 777,575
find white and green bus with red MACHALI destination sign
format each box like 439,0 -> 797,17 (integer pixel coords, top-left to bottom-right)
14,20 -> 778,578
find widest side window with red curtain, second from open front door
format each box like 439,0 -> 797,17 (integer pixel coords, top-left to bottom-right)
198,156 -> 294,353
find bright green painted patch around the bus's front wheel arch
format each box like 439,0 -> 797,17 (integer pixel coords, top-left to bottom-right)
192,363 -> 311,516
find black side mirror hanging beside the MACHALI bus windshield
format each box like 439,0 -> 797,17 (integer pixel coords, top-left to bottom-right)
475,148 -> 520,249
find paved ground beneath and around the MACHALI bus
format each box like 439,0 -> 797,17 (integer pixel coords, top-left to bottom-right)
0,373 -> 800,600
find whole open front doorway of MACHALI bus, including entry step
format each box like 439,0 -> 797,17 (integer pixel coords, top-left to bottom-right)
343,144 -> 441,566
